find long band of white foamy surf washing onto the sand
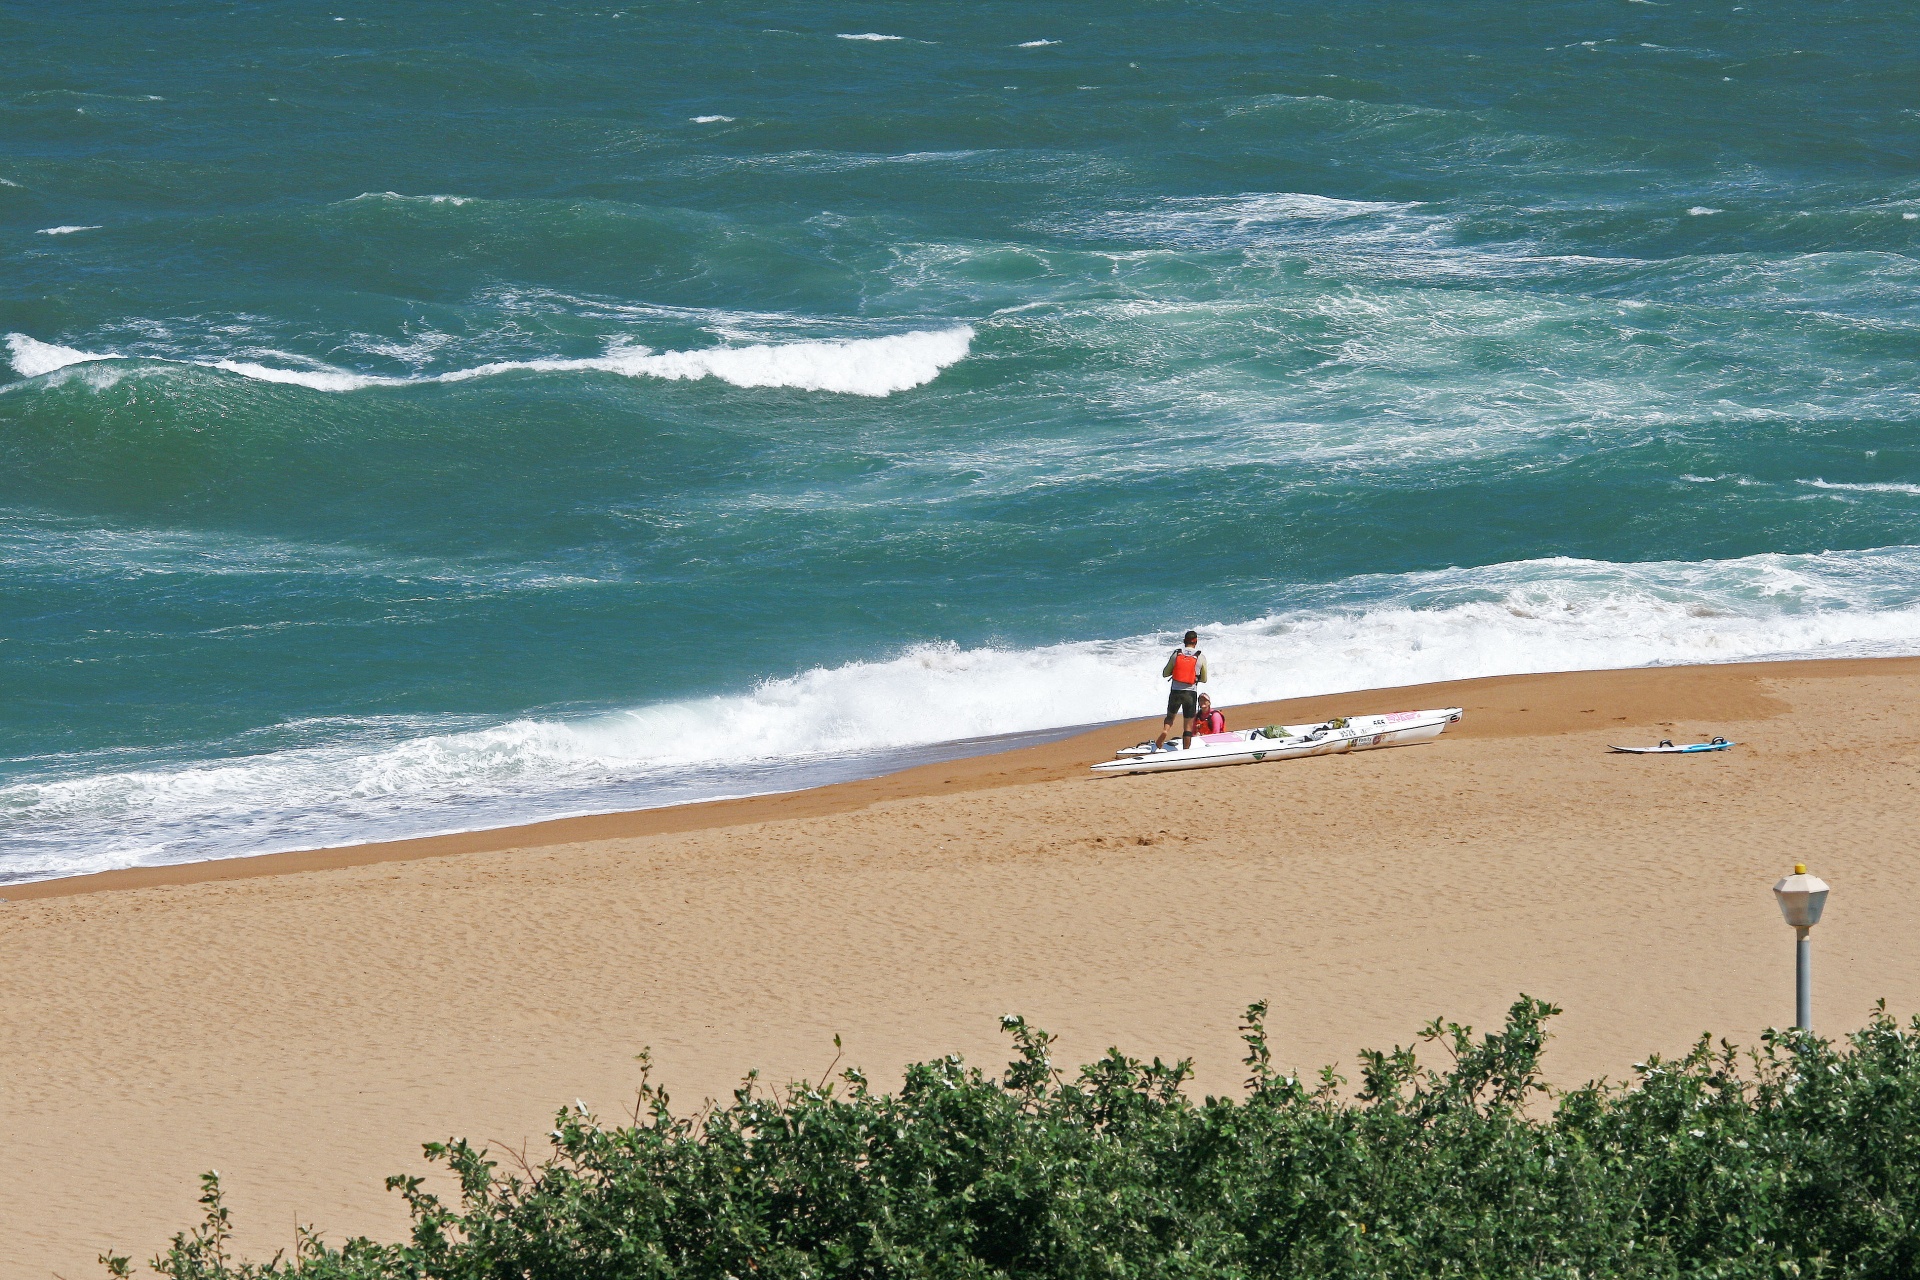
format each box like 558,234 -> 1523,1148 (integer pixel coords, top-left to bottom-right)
11,547 -> 1920,875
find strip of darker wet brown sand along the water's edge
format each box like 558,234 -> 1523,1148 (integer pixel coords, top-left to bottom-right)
11,656 -> 1920,902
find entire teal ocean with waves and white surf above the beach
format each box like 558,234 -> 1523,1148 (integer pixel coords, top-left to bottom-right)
0,0 -> 1920,881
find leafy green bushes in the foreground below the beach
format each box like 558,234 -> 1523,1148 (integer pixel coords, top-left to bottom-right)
102,996 -> 1920,1280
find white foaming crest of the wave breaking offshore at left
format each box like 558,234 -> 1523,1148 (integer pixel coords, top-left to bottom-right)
8,324 -> 973,395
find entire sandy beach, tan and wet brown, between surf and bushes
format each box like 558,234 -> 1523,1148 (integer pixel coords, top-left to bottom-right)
0,658 -> 1920,1280
